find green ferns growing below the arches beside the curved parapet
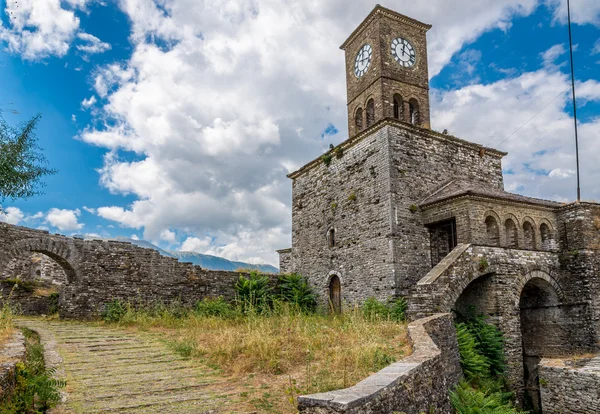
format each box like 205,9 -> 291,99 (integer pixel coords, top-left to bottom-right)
450,314 -> 526,414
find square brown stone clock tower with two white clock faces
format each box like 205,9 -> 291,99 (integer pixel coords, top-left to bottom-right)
340,5 -> 431,137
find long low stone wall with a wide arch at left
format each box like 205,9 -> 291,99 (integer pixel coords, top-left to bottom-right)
0,223 -> 244,318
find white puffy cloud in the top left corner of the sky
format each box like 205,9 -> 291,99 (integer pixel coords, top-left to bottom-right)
0,0 -> 87,60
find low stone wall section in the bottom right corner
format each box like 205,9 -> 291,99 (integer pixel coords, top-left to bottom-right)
540,358 -> 600,414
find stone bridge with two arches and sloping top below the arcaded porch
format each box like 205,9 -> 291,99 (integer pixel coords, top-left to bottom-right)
409,244 -> 599,404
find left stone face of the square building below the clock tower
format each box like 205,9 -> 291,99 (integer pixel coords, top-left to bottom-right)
291,124 -> 395,304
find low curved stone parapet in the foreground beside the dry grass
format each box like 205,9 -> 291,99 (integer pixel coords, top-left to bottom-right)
298,314 -> 462,414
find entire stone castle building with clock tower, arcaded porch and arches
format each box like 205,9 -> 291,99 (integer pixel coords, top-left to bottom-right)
278,5 -> 600,408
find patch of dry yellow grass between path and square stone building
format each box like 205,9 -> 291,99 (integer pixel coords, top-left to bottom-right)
105,302 -> 410,413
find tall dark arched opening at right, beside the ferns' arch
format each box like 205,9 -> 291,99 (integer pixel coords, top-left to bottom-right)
519,277 -> 568,413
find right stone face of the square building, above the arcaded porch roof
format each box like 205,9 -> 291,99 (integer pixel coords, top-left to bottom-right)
387,124 -> 503,296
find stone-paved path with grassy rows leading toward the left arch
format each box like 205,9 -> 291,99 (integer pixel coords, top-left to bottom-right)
18,319 -> 228,413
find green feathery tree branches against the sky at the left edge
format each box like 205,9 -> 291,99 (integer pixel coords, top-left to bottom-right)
0,114 -> 56,211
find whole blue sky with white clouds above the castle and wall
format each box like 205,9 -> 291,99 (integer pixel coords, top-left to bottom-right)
0,0 -> 600,264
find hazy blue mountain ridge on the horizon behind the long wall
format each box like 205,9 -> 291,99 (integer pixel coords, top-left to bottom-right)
74,234 -> 279,273
